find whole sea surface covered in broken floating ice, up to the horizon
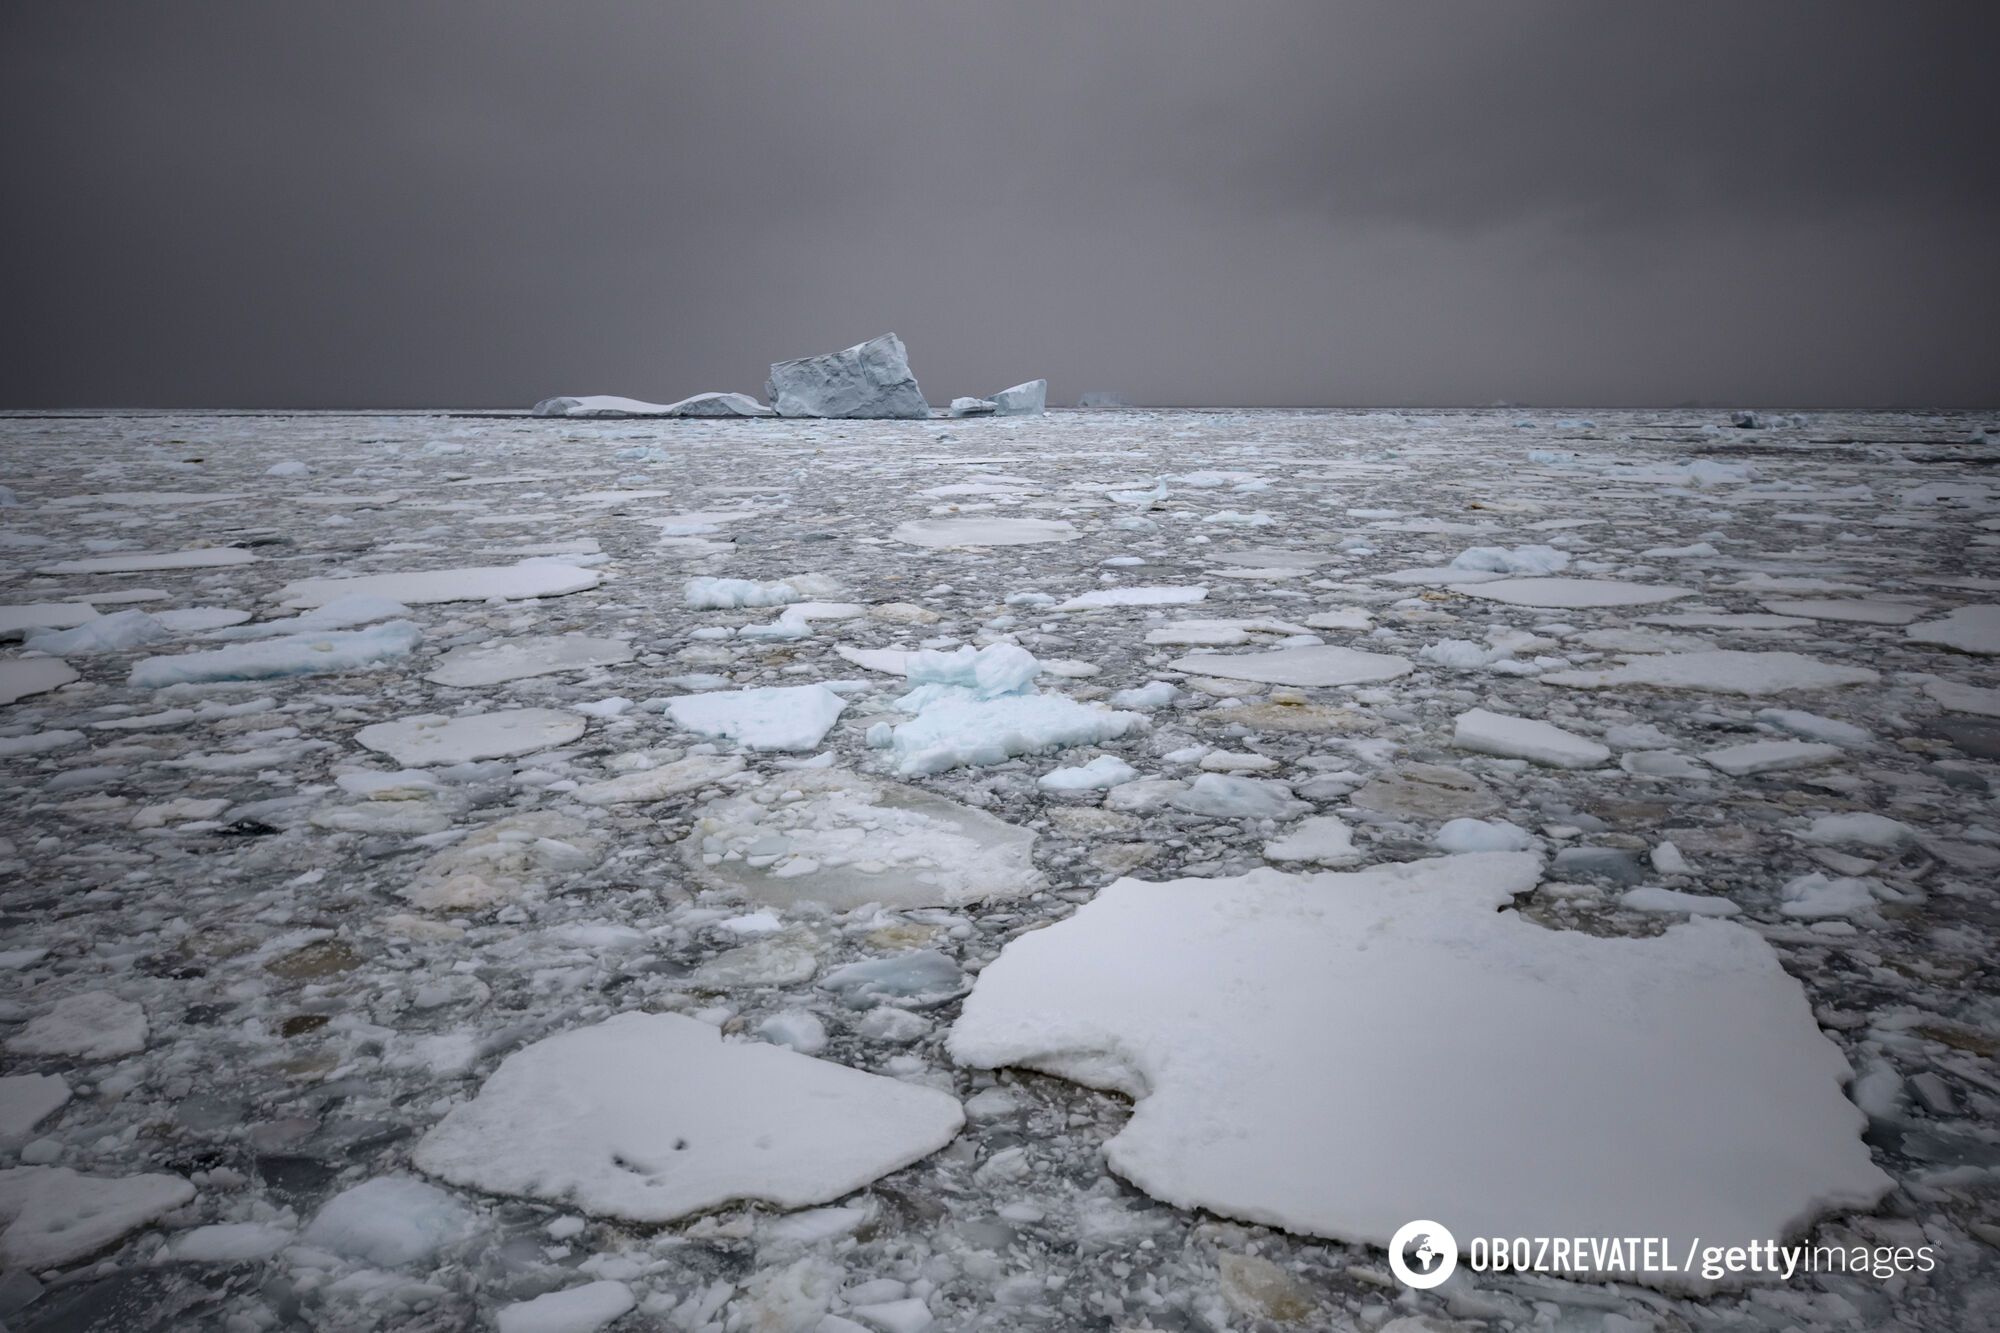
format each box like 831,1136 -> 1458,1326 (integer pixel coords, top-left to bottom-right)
0,408 -> 2000,1333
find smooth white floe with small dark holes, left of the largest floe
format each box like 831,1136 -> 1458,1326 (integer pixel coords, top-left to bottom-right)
412,1013 -> 964,1223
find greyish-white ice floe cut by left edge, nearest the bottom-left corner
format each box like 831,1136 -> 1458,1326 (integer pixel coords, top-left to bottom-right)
0,1167 -> 194,1269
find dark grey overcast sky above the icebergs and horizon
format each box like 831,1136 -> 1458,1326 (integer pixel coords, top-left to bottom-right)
0,0 -> 2000,406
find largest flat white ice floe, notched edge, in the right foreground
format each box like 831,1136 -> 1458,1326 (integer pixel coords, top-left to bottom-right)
950,853 -> 1890,1289
